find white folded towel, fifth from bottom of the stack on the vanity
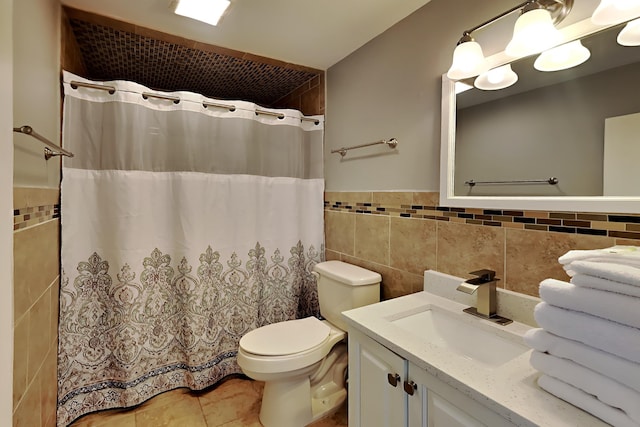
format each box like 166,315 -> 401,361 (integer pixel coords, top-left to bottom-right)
540,279 -> 640,328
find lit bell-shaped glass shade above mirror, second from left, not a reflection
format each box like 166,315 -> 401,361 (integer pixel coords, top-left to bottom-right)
505,2 -> 562,57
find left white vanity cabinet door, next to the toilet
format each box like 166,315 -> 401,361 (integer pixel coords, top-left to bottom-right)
348,331 -> 407,427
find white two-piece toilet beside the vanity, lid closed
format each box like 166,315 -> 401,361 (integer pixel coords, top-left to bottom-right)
238,261 -> 381,427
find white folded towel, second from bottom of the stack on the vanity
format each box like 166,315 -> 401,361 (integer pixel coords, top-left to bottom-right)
530,351 -> 640,423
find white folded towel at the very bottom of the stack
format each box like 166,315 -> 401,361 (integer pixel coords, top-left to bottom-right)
538,375 -> 640,427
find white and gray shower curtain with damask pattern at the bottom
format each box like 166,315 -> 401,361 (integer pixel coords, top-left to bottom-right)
58,72 -> 324,425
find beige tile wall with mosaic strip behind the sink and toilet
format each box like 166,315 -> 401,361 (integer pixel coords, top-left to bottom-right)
325,192 -> 640,299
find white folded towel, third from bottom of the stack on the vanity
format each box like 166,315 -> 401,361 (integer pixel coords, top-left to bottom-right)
524,328 -> 640,393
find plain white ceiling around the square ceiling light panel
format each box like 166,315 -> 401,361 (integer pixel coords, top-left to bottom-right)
61,0 -> 430,70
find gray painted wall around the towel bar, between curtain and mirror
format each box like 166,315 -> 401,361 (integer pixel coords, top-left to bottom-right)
324,0 -> 597,191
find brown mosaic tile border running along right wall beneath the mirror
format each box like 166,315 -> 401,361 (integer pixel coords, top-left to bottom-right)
324,200 -> 640,240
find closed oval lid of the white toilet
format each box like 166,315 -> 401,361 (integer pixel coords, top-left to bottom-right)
240,317 -> 331,356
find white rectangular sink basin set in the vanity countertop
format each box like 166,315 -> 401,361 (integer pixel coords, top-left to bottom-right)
389,305 -> 529,368
